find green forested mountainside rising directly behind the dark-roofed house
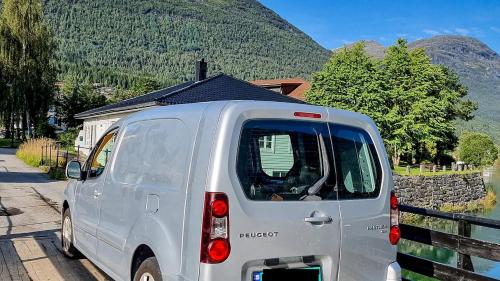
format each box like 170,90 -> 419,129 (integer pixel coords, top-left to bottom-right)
44,0 -> 330,87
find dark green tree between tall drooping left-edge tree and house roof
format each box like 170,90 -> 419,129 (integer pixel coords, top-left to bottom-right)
57,75 -> 106,128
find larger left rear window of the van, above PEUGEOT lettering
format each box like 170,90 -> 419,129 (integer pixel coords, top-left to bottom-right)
237,120 -> 337,201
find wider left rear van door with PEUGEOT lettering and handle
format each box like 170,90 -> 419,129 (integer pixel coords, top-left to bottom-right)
200,107 -> 340,281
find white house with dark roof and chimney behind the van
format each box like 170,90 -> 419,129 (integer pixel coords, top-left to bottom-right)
75,60 -> 303,153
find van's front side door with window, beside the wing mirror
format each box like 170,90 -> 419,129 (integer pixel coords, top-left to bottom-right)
72,130 -> 116,257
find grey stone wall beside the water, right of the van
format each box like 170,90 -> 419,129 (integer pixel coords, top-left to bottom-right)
394,173 -> 486,209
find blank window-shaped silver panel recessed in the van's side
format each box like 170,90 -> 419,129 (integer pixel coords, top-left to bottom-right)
111,119 -> 192,189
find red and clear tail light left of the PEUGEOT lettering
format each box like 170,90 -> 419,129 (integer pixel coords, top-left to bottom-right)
200,192 -> 231,264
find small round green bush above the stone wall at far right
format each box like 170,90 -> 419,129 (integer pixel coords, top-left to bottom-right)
458,132 -> 498,167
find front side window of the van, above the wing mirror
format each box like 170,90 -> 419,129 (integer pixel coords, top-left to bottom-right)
88,131 -> 116,178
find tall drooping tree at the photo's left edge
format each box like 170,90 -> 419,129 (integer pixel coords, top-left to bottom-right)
0,0 -> 56,138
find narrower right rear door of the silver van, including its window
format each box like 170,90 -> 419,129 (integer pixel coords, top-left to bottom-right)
330,121 -> 395,281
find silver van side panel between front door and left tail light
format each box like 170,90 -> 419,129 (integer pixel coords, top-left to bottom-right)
97,118 -> 194,279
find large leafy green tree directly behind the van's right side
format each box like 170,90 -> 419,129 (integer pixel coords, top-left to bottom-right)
306,39 -> 477,165
